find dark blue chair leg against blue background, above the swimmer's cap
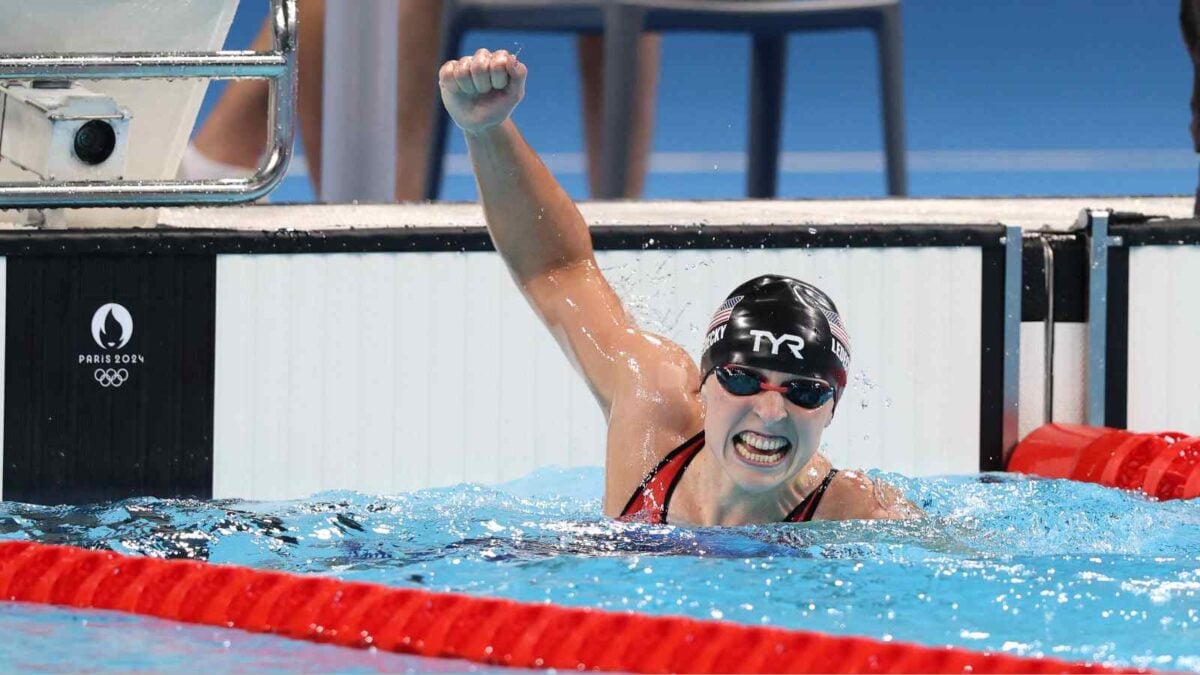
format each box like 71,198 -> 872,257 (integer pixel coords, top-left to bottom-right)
746,34 -> 787,199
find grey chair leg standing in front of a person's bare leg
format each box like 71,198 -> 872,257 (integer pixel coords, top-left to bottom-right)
596,2 -> 643,199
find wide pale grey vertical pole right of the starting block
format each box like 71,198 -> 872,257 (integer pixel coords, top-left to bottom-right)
320,0 -> 400,202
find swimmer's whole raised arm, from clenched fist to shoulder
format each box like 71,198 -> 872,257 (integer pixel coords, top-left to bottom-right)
438,49 -> 698,428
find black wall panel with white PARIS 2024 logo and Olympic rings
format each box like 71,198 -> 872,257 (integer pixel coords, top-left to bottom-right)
4,256 -> 216,503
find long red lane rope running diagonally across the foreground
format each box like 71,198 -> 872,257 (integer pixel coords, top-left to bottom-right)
0,542 -> 1137,673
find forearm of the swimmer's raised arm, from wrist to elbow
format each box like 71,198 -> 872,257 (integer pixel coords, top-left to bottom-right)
466,119 -> 593,282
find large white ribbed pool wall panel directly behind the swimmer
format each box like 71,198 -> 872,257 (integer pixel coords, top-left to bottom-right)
214,247 -> 982,498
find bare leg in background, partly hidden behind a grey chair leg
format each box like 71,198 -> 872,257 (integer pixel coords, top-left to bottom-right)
578,35 -> 661,198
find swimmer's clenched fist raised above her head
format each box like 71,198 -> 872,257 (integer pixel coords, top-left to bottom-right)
438,49 -> 528,133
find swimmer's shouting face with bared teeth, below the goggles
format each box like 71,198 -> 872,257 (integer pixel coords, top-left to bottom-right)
700,366 -> 834,492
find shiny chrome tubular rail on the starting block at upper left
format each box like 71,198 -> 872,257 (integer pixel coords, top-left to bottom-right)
0,0 -> 296,209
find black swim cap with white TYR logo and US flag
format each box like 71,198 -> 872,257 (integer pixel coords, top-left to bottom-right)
700,274 -> 850,399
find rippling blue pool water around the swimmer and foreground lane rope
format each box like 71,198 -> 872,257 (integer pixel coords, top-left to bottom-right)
0,468 -> 1200,673
